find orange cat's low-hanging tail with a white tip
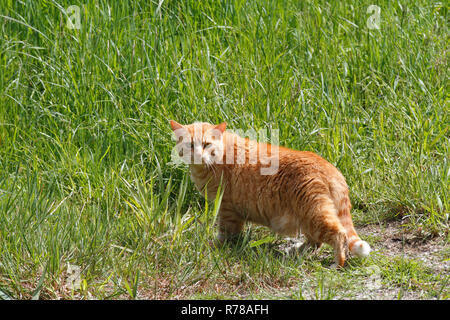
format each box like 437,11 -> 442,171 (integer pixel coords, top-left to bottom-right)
338,198 -> 371,257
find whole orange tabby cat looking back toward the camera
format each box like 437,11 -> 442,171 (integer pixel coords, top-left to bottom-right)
170,121 -> 370,266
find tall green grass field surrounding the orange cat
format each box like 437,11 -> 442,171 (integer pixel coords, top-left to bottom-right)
0,0 -> 450,299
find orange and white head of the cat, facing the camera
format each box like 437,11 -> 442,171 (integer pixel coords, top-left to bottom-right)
170,120 -> 227,165
